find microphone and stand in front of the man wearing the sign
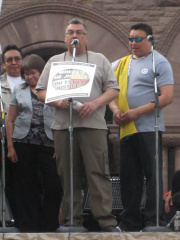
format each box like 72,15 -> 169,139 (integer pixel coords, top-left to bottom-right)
56,39 -> 87,233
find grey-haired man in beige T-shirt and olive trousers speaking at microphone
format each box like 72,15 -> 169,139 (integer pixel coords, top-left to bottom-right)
37,19 -> 119,232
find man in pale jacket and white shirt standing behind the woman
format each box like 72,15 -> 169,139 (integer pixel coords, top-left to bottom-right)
0,45 -> 25,227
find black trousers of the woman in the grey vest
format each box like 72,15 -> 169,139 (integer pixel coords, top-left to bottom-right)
14,143 -> 62,232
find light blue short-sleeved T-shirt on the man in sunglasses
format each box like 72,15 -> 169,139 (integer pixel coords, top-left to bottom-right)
127,51 -> 174,132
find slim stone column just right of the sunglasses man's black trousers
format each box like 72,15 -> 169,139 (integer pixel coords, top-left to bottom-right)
162,147 -> 168,194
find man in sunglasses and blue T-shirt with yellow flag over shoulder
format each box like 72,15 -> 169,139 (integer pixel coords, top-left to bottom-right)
110,23 -> 174,231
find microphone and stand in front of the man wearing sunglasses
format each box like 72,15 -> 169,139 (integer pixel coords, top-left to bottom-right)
143,36 -> 171,232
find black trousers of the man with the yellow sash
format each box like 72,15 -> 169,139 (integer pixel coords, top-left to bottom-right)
120,132 -> 164,231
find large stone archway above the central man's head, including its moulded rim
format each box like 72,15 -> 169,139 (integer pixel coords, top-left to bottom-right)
0,1 -> 129,61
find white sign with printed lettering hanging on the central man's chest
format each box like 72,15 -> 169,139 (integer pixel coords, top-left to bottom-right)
45,62 -> 96,103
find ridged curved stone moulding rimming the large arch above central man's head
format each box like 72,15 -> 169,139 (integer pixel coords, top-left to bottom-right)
0,1 -> 128,48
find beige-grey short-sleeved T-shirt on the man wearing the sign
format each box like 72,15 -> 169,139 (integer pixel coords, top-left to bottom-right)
36,51 -> 119,130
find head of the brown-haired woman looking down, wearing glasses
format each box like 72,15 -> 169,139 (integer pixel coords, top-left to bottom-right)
22,54 -> 45,87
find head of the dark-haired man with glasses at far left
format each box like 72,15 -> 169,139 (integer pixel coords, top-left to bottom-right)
2,45 -> 22,77
